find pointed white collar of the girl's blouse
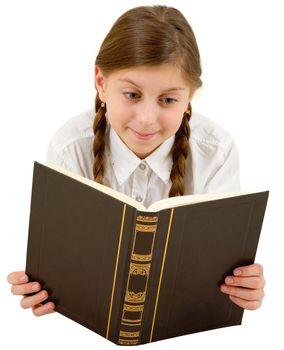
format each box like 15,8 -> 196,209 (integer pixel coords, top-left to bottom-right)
109,126 -> 174,185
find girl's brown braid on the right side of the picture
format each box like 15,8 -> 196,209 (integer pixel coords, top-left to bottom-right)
169,103 -> 192,197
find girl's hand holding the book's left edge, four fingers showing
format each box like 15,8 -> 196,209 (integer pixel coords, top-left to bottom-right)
7,271 -> 55,316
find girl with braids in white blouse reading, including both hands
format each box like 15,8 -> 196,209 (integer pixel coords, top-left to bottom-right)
8,6 -> 265,316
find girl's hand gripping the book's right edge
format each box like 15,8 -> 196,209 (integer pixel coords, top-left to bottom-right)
220,264 -> 265,310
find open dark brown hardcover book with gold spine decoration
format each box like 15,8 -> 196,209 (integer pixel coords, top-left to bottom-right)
26,162 -> 269,345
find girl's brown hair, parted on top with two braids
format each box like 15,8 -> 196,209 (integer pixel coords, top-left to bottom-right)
93,5 -> 202,197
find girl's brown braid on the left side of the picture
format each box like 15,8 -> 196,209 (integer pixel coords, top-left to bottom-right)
93,94 -> 107,184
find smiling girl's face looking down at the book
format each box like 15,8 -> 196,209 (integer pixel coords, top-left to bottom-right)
95,65 -> 193,159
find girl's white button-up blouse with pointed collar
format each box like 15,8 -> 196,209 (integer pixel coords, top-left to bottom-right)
47,109 -> 240,207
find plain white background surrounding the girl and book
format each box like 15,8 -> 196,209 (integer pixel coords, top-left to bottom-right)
0,0 -> 284,349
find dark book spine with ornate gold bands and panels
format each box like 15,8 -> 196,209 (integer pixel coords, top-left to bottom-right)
117,211 -> 158,345
